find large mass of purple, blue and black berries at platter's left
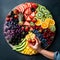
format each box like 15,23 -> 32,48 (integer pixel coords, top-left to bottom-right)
4,11 -> 27,45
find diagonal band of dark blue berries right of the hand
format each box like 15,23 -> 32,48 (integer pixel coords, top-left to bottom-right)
33,30 -> 48,48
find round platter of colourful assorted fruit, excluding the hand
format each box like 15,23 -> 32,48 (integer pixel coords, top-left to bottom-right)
4,2 -> 56,55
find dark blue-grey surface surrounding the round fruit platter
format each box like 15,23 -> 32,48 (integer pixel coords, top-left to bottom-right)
0,0 -> 60,60
